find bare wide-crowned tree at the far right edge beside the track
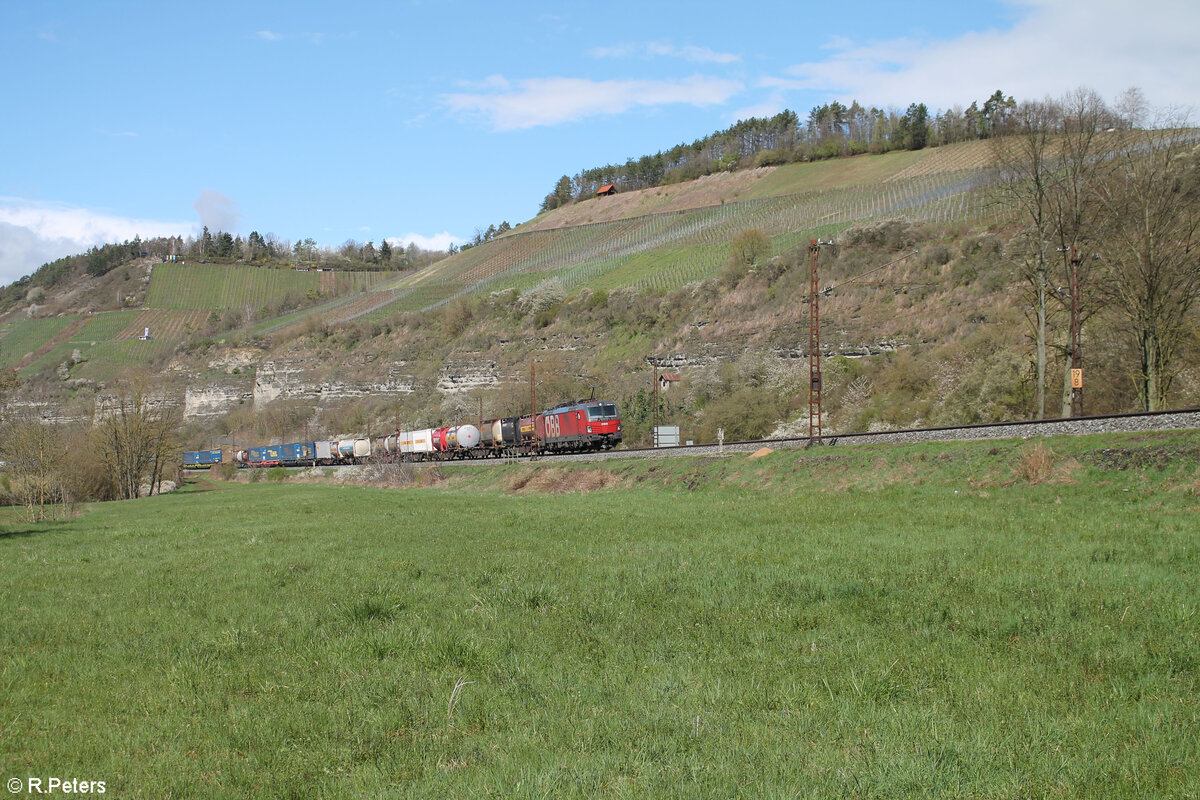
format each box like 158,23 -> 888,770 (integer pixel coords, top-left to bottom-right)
1097,112 -> 1200,411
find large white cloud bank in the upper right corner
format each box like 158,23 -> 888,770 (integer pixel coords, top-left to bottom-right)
766,0 -> 1200,108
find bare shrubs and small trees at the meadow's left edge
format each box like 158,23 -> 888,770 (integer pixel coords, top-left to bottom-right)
0,371 -> 182,521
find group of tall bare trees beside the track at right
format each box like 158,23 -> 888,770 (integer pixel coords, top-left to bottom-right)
994,89 -> 1200,417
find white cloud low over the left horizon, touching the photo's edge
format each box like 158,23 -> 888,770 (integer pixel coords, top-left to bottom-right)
0,197 -> 189,284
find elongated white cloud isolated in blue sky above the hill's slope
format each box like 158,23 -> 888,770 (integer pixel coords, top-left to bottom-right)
443,76 -> 742,131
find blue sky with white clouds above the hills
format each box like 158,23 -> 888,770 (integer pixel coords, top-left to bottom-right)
0,0 -> 1200,283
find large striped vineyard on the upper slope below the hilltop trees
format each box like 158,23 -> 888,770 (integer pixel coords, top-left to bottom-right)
342,169 -> 992,319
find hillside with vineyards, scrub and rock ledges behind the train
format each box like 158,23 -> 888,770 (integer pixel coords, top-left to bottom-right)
0,143 -> 1200,443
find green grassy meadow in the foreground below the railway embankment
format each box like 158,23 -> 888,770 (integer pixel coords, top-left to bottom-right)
0,434 -> 1200,799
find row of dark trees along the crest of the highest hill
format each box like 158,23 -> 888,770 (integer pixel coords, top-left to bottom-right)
541,90 -> 1016,211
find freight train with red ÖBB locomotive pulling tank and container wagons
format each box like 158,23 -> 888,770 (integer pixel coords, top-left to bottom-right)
184,399 -> 622,469
